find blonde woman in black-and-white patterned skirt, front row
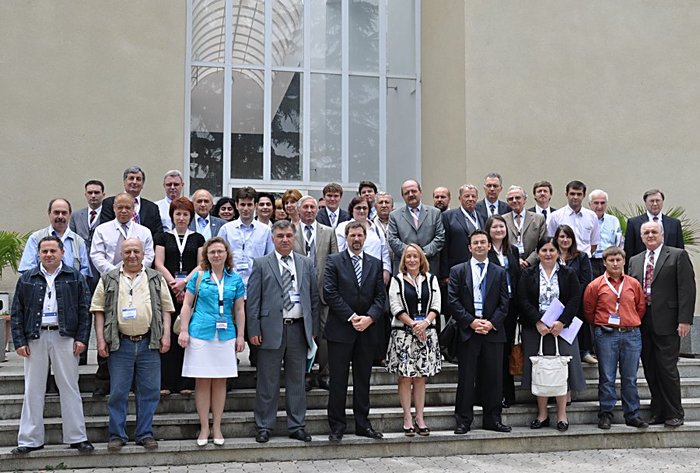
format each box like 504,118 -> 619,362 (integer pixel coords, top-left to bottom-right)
387,243 -> 442,437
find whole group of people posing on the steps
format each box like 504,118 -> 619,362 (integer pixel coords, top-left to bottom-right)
11,166 -> 695,454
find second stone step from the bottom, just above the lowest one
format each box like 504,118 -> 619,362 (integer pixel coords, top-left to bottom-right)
0,398 -> 700,447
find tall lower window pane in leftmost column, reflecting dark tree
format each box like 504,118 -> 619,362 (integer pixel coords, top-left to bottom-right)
190,67 -> 224,195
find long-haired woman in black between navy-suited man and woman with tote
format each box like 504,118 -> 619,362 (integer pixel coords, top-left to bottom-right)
485,215 -> 520,408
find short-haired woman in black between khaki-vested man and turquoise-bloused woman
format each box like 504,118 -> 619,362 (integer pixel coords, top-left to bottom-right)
154,197 -> 204,396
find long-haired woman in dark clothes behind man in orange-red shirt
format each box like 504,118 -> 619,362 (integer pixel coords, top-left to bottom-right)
554,225 -> 598,364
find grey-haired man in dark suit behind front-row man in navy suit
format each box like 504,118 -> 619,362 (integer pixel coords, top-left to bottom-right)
442,184 -> 485,280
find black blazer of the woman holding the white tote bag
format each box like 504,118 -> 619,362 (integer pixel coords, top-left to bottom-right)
518,263 -> 581,327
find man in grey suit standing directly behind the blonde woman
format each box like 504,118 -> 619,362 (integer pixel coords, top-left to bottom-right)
386,179 -> 445,274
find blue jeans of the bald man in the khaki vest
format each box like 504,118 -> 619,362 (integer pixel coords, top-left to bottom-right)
107,337 -> 160,442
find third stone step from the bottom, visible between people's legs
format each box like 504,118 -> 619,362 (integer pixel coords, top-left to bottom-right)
0,378 -> 700,420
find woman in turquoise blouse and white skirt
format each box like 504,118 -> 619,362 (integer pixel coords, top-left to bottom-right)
178,237 -> 245,447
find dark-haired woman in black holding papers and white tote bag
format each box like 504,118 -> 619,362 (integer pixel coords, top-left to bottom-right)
517,237 -> 586,432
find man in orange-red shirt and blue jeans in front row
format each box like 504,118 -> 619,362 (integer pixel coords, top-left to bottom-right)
583,246 -> 649,430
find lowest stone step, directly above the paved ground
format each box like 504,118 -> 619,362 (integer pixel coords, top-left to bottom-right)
0,421 -> 700,471
